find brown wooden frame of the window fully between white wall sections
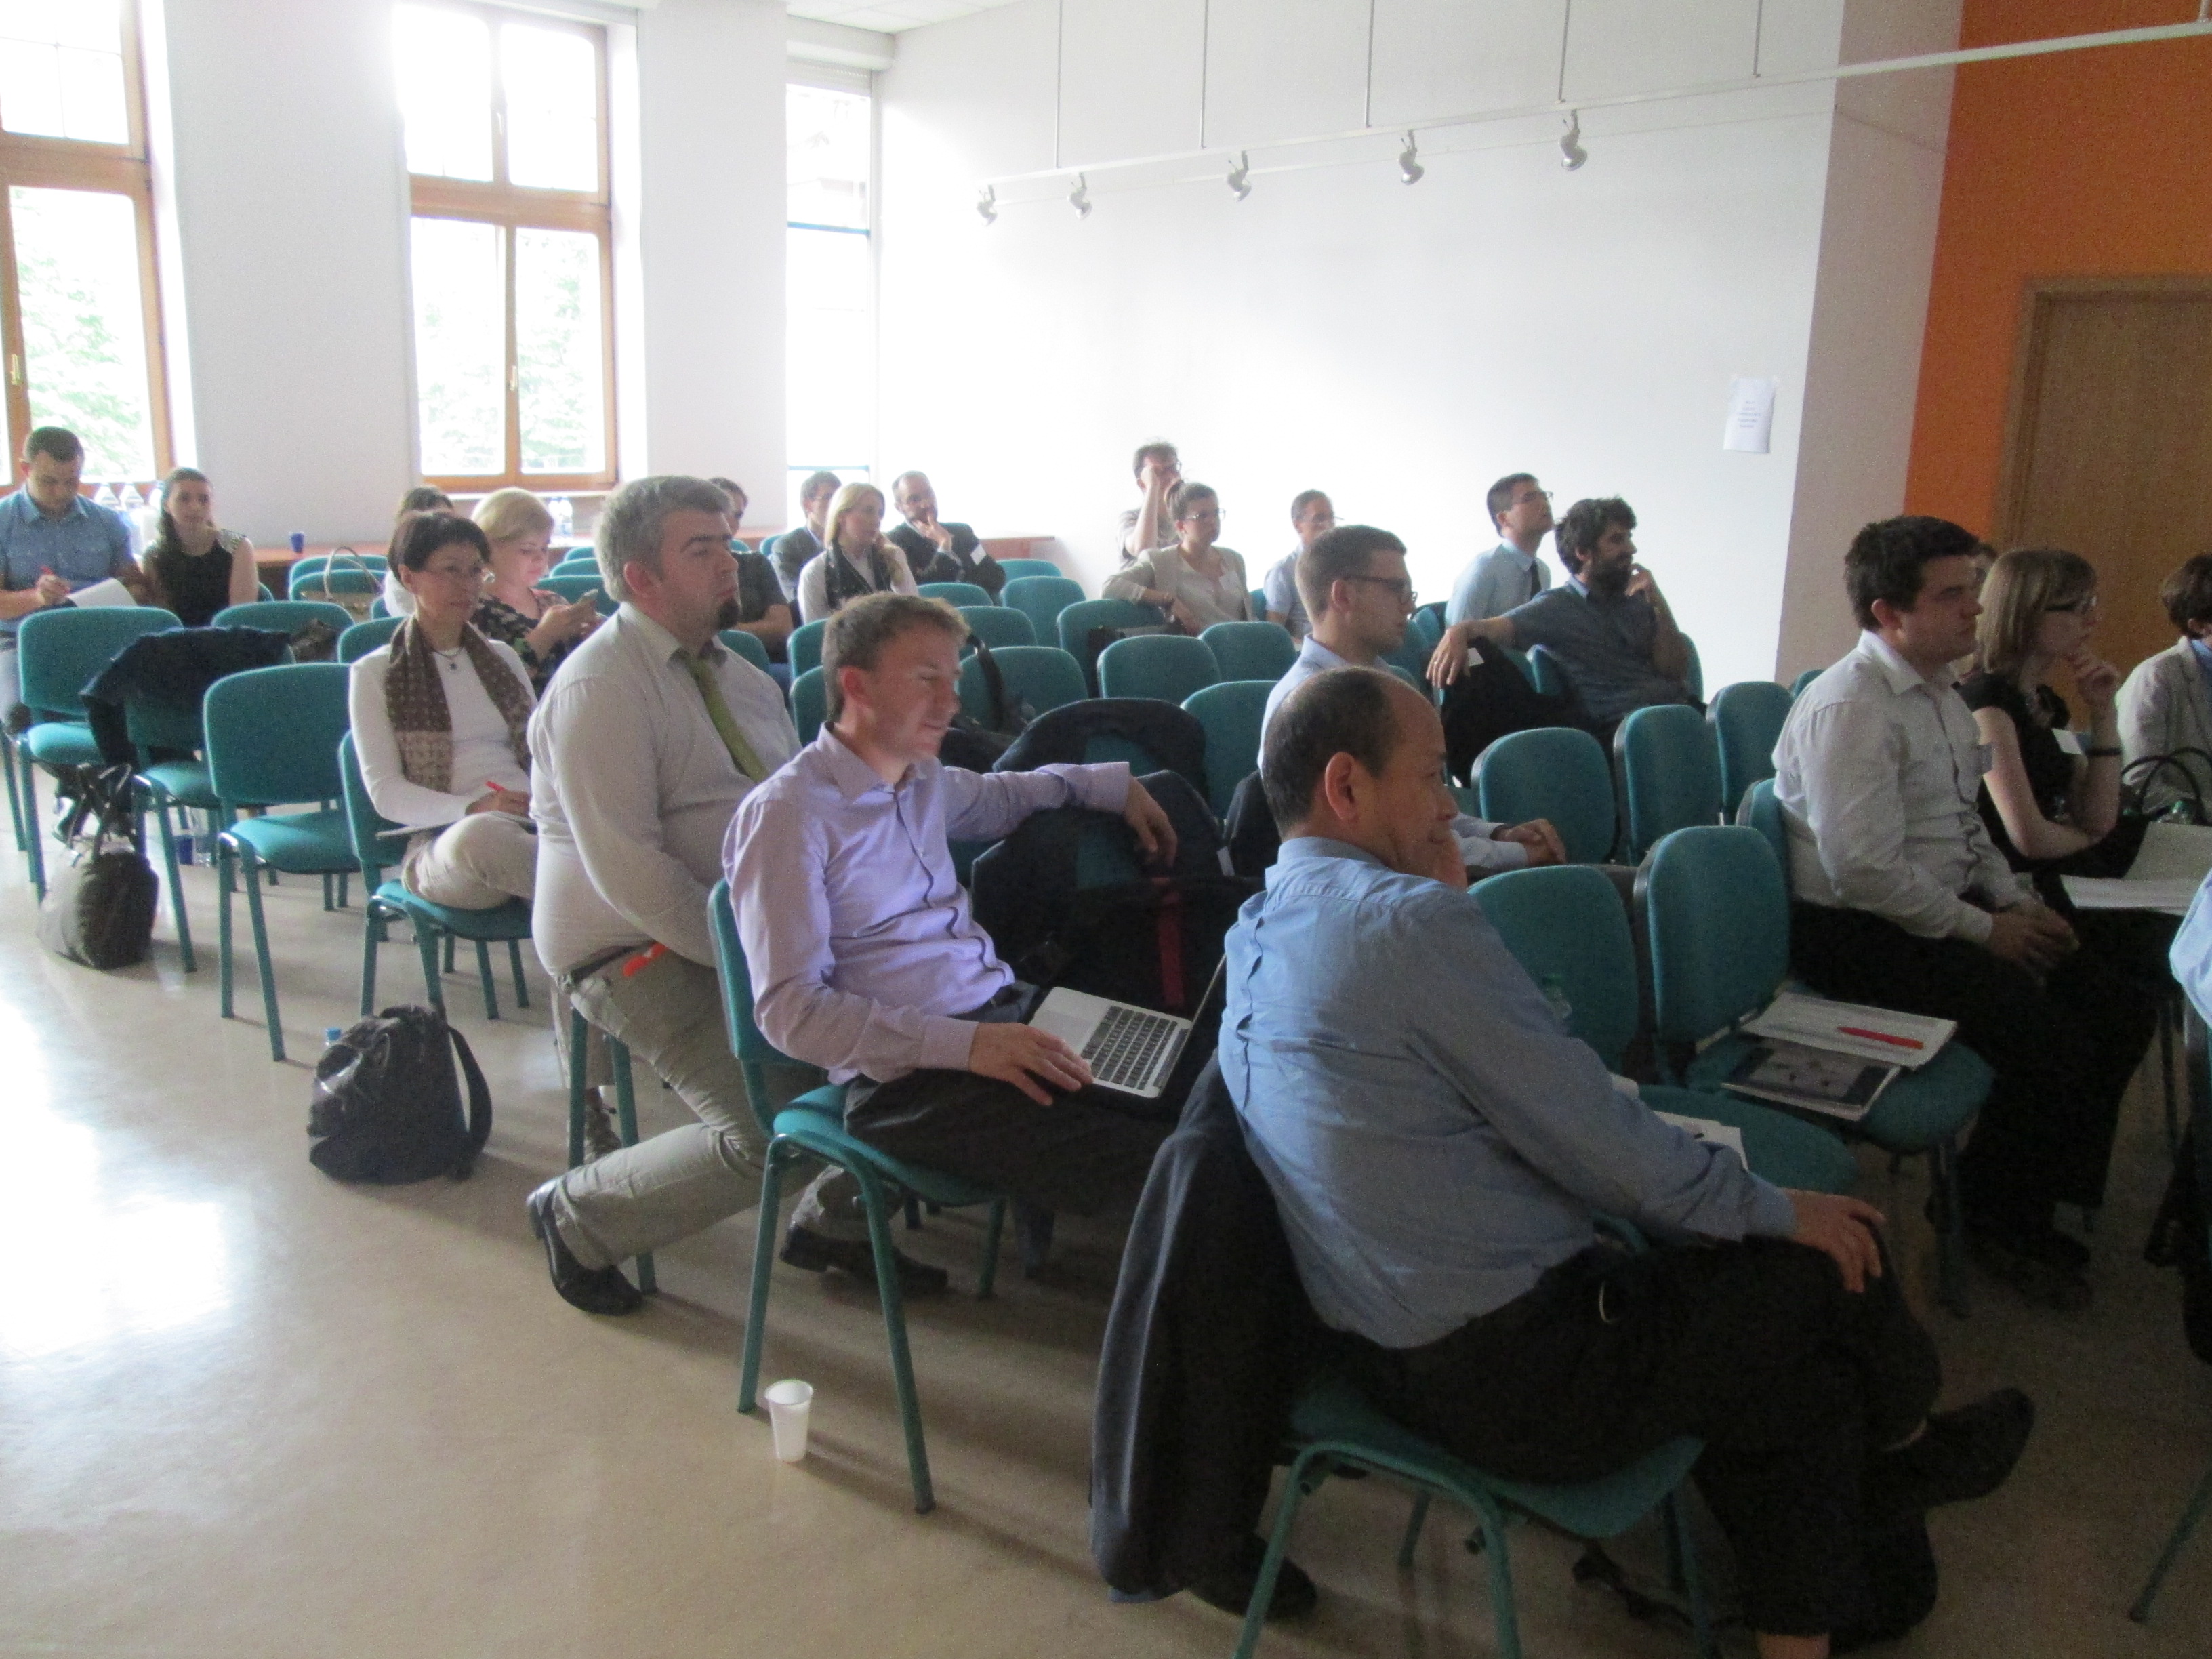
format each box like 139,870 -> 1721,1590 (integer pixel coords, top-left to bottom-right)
407,0 -> 619,495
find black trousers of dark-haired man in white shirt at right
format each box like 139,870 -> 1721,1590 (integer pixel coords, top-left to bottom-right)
1790,903 -> 2156,1230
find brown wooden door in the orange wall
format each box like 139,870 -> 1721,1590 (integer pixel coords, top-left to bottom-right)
1997,276 -> 2212,672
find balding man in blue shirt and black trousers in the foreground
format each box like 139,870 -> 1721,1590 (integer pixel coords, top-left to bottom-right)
1218,668 -> 2033,1659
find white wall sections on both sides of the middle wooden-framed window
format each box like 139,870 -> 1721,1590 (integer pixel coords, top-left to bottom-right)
148,0 -> 785,542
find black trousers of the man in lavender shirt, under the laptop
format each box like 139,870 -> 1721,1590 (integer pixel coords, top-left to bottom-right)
845,987 -> 1174,1214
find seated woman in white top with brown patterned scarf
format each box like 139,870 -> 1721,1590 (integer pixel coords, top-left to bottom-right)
352,513 -> 537,909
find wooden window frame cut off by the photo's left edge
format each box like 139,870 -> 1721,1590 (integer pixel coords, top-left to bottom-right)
0,0 -> 177,485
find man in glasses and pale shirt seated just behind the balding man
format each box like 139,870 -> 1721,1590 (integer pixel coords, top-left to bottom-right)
1258,525 -> 1566,876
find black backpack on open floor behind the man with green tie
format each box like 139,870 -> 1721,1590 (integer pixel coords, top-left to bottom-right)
308,1004 -> 491,1186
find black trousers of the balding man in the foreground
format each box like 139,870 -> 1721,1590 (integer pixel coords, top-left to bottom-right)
1365,1239 -> 1942,1637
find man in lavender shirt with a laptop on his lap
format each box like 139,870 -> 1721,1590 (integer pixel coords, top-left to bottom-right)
723,593 -> 1174,1228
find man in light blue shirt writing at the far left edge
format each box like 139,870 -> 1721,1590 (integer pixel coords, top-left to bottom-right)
0,427 -> 146,719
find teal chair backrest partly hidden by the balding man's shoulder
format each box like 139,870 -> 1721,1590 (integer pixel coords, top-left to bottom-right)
1471,865 -> 1641,1071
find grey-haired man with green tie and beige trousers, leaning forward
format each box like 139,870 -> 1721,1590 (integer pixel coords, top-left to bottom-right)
529,478 -> 945,1314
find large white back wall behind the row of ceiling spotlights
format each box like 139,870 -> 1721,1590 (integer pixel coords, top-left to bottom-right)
880,0 -> 1955,686
